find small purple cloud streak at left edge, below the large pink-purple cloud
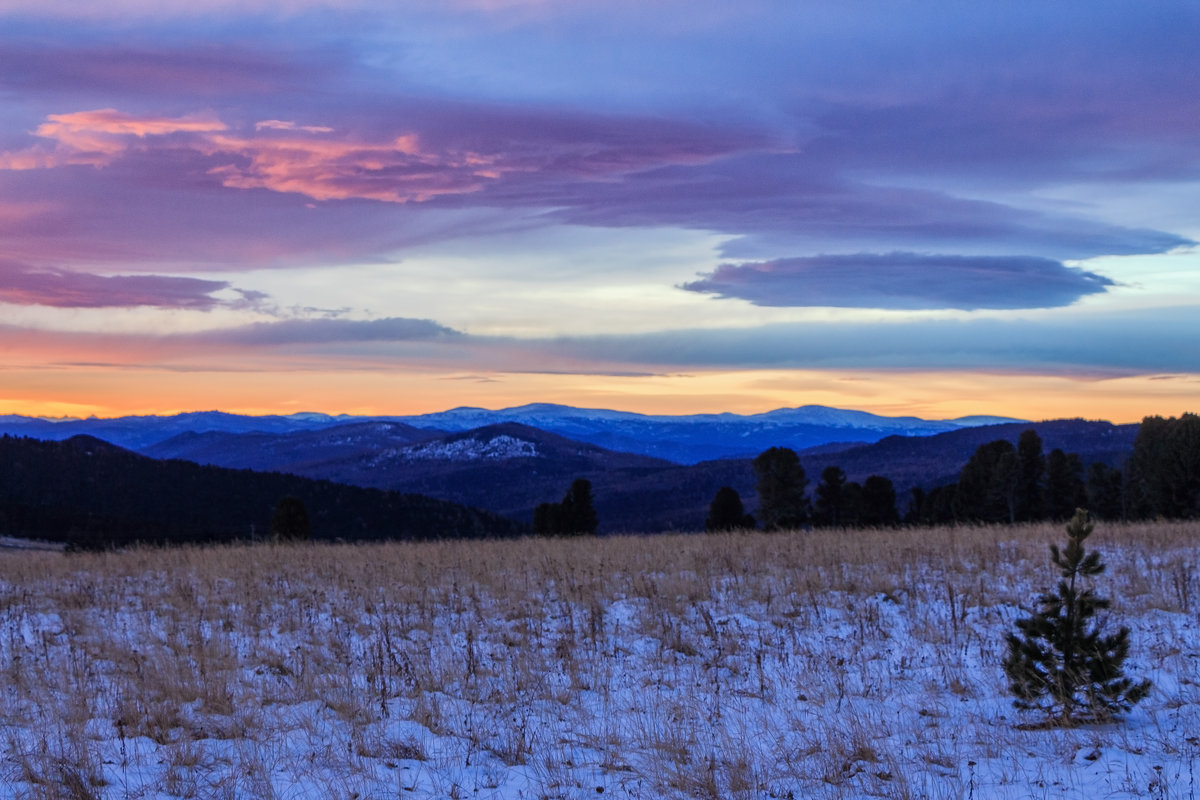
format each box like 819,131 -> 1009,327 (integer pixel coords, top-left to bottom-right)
0,260 -> 236,311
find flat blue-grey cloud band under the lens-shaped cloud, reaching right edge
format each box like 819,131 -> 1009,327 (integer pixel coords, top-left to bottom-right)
539,306 -> 1200,374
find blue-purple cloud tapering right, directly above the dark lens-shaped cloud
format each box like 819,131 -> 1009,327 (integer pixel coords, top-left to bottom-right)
528,152 -> 1193,259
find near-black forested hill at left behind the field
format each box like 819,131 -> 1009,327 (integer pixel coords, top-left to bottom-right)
0,435 -> 520,546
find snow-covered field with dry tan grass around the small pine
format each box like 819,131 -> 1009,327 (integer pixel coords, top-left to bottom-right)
0,524 -> 1200,800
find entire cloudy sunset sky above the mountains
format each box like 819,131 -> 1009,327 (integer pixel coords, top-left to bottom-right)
0,0 -> 1200,421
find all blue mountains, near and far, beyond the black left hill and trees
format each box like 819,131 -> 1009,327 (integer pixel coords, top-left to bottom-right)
0,404 -> 1138,533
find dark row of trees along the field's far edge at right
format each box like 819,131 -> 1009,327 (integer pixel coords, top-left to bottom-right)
706,414 -> 1200,530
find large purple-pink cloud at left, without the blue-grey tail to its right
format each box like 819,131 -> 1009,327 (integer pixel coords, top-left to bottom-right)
0,101 -> 763,269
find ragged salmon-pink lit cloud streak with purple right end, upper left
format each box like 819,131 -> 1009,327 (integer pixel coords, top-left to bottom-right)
0,109 -> 753,203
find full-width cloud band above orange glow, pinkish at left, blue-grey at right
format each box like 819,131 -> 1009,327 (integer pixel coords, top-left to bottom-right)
0,299 -> 1200,377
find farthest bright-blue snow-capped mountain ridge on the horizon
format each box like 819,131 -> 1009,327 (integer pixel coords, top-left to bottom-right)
0,403 -> 1020,464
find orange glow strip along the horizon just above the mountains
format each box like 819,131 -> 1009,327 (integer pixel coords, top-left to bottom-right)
0,366 -> 1200,422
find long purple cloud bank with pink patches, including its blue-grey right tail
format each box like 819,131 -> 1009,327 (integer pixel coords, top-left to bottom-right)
0,100 -> 1188,271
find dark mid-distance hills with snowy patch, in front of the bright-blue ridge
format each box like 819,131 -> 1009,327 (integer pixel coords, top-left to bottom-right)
143,412 -> 1138,531
